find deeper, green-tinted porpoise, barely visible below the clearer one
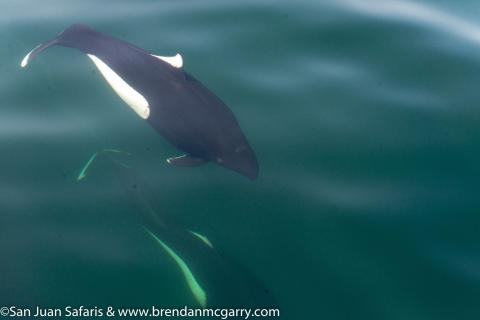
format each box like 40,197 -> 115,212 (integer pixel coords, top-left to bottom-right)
82,152 -> 278,309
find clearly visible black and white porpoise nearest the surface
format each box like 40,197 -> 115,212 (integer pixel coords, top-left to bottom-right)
21,24 -> 259,180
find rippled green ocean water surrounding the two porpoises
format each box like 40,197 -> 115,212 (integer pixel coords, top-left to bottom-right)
0,0 -> 480,320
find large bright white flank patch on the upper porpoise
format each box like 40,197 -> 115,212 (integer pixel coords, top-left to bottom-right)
87,54 -> 150,119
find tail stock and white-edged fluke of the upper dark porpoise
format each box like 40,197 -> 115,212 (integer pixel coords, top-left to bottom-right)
20,24 -> 100,68
